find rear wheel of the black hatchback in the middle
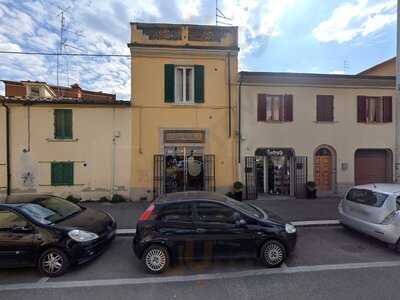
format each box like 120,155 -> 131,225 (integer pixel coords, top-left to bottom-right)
142,245 -> 169,273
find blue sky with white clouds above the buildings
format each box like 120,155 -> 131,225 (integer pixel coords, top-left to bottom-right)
0,0 -> 396,100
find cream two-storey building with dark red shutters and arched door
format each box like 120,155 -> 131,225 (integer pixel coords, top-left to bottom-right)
239,72 -> 396,198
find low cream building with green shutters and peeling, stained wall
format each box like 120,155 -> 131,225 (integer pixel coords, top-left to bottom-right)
0,97 -> 132,200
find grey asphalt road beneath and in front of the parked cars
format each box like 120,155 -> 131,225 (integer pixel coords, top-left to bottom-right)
0,226 -> 400,300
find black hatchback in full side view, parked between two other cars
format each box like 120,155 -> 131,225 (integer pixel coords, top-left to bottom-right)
133,192 -> 297,273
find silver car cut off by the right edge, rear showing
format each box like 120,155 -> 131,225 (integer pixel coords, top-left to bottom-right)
338,184 -> 400,251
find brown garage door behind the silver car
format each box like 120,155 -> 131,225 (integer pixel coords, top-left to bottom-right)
355,149 -> 392,184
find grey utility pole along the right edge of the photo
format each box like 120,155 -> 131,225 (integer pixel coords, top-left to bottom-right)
395,0 -> 400,183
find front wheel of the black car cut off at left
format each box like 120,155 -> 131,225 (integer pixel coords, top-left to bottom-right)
38,248 -> 69,277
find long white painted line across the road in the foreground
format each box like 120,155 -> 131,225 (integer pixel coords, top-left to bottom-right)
0,261 -> 400,292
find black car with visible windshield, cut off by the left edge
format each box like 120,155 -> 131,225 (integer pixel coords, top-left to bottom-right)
0,195 -> 117,277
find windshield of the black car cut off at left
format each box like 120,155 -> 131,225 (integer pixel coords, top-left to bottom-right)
20,197 -> 82,224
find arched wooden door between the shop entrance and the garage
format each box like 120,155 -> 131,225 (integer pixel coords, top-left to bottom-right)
314,145 -> 336,192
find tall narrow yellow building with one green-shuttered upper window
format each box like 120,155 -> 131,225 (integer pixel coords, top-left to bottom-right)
128,23 -> 239,200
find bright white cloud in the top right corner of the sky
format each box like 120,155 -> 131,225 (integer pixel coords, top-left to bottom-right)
313,0 -> 396,43
